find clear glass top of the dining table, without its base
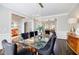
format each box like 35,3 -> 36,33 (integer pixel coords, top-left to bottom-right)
18,36 -> 48,49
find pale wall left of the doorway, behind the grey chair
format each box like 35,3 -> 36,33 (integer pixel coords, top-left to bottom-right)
0,5 -> 11,48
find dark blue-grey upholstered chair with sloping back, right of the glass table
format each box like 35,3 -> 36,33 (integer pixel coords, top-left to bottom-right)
38,33 -> 56,55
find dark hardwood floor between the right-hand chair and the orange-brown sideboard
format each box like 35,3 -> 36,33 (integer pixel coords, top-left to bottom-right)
54,39 -> 75,55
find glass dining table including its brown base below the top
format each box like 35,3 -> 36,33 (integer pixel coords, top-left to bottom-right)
17,36 -> 48,55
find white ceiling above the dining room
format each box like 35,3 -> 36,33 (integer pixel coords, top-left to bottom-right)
2,3 -> 77,16
